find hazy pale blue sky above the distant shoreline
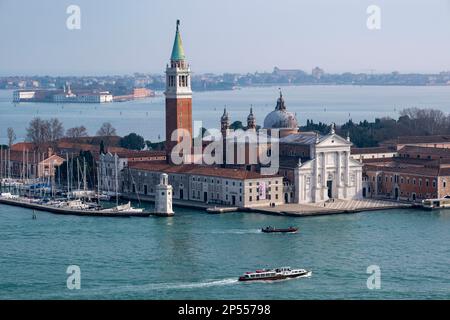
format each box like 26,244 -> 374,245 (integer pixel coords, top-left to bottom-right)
0,0 -> 450,75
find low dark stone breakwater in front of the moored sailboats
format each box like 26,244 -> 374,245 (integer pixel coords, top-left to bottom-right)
0,198 -> 151,218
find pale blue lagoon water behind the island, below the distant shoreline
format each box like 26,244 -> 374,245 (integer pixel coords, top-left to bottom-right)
0,86 -> 450,143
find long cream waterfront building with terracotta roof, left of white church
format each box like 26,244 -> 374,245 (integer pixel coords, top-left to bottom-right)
119,162 -> 284,207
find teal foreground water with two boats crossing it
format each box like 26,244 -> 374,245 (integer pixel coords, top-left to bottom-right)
0,202 -> 450,299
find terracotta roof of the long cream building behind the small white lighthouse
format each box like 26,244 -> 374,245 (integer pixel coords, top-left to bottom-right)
129,162 -> 278,180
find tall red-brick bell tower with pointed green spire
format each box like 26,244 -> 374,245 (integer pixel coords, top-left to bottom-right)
165,20 -> 192,160
